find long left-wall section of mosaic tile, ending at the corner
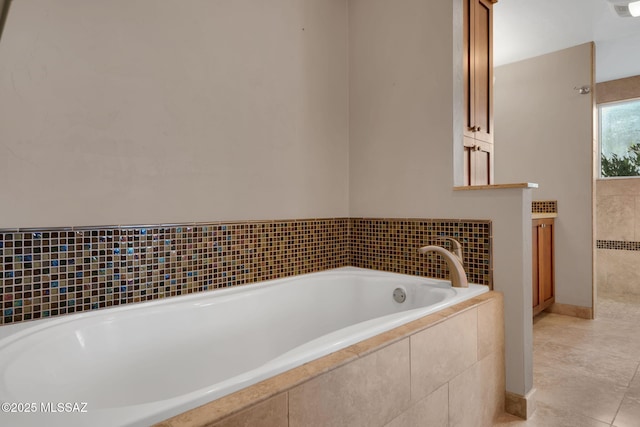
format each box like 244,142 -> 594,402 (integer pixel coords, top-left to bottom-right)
0,218 -> 349,324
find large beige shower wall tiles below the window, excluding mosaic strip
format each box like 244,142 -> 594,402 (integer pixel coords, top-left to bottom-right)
596,178 -> 640,296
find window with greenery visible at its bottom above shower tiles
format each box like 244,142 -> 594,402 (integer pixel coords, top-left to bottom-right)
598,99 -> 640,178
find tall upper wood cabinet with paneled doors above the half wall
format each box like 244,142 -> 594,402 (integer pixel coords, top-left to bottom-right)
463,0 -> 497,185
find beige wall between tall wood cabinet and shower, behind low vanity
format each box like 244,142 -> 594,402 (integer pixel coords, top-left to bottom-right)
495,43 -> 593,307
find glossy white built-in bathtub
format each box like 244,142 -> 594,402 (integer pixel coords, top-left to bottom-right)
0,267 -> 488,426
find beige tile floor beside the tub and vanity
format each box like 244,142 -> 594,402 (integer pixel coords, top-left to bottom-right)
495,296 -> 640,427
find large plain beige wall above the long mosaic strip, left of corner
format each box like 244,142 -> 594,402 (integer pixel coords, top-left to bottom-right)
0,0 -> 348,227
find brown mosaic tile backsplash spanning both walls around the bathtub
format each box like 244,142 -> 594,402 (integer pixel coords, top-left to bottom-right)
0,218 -> 492,324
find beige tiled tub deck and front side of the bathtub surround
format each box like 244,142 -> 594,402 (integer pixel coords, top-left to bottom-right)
156,292 -> 505,427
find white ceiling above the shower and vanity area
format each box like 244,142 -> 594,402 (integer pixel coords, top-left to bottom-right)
493,0 -> 640,81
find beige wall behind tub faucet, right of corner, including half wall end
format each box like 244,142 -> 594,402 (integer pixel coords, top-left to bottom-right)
349,0 -> 533,395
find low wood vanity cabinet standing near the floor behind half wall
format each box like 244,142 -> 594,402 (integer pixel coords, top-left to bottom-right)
531,218 -> 555,316
